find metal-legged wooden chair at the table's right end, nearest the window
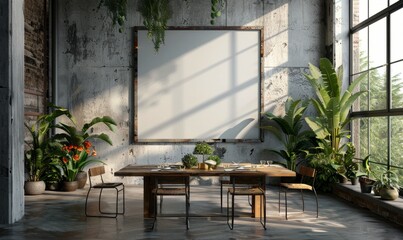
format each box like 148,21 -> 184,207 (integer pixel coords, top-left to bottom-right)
278,166 -> 319,220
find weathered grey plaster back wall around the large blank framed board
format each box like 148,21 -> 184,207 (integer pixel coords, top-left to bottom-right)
55,0 -> 325,183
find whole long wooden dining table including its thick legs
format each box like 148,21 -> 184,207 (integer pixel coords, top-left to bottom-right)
114,164 -> 296,218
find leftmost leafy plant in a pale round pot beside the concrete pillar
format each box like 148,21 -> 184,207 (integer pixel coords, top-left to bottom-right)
24,105 -> 69,195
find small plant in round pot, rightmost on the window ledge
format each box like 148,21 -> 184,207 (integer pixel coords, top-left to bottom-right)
379,170 -> 400,200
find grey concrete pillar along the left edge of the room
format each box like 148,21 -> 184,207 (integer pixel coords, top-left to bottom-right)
0,0 -> 24,224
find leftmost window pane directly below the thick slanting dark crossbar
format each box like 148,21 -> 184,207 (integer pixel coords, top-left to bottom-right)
352,28 -> 368,73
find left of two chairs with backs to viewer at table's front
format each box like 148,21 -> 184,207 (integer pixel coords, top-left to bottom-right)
151,175 -> 190,230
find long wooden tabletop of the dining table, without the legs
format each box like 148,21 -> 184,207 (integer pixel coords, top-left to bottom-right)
115,164 -> 296,177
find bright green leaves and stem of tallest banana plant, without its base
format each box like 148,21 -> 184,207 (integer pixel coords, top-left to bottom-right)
304,58 -> 365,158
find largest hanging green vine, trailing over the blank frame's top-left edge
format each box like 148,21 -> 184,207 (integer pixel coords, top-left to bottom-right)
138,0 -> 172,52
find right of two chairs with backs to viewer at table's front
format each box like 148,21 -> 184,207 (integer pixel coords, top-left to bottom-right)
227,174 -> 266,230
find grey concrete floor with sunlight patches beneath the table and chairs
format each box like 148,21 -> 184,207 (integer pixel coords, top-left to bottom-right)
0,186 -> 403,240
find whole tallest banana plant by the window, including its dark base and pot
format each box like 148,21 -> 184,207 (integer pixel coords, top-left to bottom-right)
304,58 -> 365,191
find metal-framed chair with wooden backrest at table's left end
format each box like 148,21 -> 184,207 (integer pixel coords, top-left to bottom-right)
85,166 -> 125,218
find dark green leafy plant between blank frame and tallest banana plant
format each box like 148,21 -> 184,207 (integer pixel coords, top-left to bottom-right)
262,98 -> 314,171
